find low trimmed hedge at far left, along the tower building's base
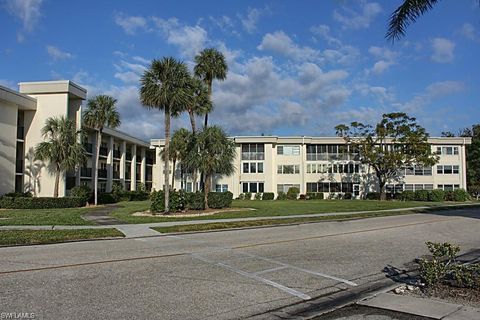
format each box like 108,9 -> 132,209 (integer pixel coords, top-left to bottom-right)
0,196 -> 85,209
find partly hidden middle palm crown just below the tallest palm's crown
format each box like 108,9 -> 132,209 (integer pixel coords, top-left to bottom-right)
187,77 -> 212,134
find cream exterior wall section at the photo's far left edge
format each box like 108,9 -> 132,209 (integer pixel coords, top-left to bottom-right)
0,100 -> 18,194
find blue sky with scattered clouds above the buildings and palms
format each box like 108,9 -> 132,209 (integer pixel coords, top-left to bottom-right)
0,0 -> 480,139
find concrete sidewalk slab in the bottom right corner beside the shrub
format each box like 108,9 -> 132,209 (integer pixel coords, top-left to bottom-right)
357,293 -> 480,320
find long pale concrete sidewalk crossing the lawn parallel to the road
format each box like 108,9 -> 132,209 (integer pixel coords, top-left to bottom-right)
0,204 -> 478,238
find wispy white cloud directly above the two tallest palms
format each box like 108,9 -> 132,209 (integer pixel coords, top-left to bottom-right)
152,17 -> 208,58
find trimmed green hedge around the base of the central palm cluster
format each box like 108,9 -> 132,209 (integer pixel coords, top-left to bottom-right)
150,190 -> 233,212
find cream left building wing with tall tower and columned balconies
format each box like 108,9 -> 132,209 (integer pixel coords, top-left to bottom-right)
0,81 -> 155,196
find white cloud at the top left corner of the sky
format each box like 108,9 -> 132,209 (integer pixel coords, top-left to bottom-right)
6,0 -> 43,42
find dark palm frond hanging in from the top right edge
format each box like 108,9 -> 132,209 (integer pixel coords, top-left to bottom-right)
385,0 -> 438,42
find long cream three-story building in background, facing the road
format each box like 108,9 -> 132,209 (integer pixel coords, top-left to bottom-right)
151,136 -> 471,197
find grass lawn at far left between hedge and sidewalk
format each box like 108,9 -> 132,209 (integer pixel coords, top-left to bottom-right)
0,208 -> 97,226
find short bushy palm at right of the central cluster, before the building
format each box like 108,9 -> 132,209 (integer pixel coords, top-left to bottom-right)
184,126 -> 236,209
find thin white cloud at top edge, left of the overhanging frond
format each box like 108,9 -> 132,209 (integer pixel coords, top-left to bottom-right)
333,1 -> 382,29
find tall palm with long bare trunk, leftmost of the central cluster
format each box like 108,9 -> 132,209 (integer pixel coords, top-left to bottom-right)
140,57 -> 191,213
